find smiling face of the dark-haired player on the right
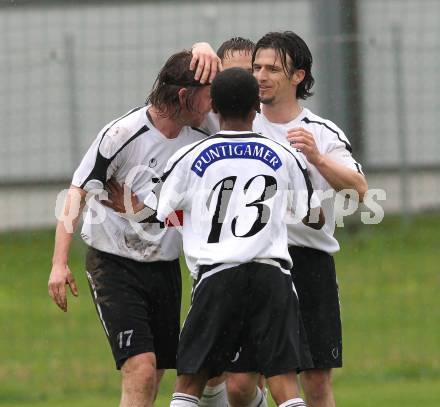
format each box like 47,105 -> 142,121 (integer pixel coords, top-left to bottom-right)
253,48 -> 296,104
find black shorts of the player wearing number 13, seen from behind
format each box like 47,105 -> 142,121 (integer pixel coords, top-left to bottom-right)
177,263 -> 312,377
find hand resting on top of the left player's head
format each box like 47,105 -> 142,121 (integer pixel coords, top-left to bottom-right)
189,42 -> 223,84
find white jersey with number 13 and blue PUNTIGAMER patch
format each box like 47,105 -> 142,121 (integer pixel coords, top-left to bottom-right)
145,131 -> 319,278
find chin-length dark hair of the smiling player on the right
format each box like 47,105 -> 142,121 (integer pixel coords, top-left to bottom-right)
252,31 -> 315,99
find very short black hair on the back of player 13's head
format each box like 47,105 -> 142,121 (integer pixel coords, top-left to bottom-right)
211,68 -> 259,119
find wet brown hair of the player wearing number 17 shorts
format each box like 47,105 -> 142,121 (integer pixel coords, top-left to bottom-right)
146,50 -> 205,119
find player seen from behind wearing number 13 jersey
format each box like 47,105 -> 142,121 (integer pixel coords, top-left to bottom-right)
145,68 -> 323,407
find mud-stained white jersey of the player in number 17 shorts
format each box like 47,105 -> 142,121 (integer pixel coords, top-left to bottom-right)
72,106 -> 206,262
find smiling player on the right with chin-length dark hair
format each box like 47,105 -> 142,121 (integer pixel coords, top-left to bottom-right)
252,31 -> 368,407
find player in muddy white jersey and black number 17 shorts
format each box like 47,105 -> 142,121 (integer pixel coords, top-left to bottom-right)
48,51 -> 211,407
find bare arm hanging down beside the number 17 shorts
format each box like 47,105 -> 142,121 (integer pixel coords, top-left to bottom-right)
48,185 -> 86,312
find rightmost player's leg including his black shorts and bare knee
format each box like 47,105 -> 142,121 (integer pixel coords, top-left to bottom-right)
289,246 -> 342,407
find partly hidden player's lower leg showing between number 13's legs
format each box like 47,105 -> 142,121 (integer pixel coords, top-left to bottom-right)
226,372 -> 267,407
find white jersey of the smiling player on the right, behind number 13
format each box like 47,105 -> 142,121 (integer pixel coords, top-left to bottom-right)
253,108 -> 362,254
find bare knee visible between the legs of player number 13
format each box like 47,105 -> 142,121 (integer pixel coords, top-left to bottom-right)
226,373 -> 259,407
